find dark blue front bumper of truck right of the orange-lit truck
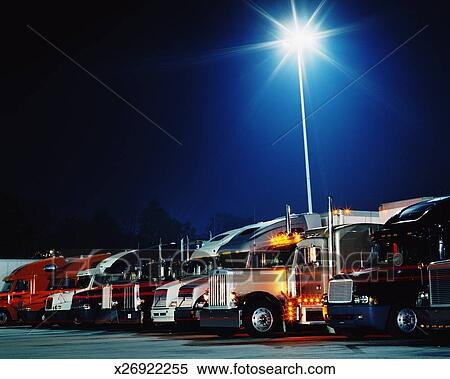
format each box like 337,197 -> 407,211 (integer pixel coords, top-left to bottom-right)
324,304 -> 390,332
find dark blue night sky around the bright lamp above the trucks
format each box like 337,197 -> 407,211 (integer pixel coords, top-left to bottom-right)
0,0 -> 450,230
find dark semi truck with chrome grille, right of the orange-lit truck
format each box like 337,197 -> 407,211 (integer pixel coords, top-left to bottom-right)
323,197 -> 450,336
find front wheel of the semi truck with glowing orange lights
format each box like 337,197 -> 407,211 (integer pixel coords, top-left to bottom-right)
244,302 -> 281,338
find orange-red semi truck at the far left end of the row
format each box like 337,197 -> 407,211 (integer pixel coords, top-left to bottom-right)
0,254 -> 109,325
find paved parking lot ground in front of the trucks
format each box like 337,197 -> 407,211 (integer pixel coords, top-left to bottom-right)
0,327 -> 450,359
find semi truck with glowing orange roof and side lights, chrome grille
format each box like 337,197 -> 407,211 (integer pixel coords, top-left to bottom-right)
200,202 -> 378,337
